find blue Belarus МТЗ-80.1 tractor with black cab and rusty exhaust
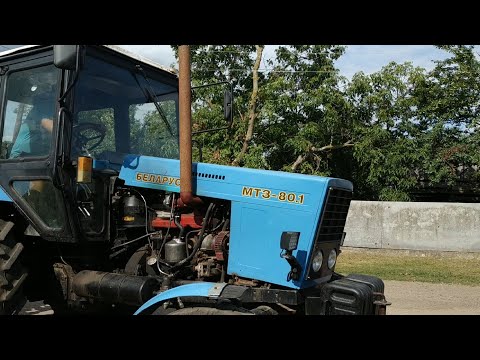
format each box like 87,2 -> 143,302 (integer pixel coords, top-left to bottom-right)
0,45 -> 388,315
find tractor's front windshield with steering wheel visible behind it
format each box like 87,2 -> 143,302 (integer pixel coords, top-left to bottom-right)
72,51 -> 179,163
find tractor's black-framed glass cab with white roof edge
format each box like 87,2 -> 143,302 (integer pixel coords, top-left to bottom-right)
0,45 -> 179,242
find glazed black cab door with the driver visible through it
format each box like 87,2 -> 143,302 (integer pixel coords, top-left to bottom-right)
0,48 -> 75,242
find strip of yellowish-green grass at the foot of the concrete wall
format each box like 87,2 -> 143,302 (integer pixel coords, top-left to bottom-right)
335,249 -> 480,286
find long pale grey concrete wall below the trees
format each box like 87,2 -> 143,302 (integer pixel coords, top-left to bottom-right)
344,201 -> 480,252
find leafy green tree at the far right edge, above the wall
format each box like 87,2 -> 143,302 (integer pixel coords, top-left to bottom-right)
416,45 -> 480,190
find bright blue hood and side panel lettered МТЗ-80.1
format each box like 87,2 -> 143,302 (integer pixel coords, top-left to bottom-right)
119,155 -> 353,289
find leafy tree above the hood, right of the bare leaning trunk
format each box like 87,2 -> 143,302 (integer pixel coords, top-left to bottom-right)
258,45 -> 353,175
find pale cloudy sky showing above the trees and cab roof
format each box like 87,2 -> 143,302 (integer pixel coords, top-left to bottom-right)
0,45 -> 480,79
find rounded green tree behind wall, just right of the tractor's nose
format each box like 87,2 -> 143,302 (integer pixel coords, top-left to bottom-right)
347,62 -> 425,201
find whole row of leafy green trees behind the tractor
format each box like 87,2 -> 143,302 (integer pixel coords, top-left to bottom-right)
170,45 -> 480,201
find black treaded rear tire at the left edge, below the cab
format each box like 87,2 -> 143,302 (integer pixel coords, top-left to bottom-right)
0,219 -> 27,315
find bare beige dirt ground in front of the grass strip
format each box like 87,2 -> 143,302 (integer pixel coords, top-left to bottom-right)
384,280 -> 480,315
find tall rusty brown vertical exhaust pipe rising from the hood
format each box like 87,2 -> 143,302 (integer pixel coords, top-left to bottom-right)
177,45 -> 203,207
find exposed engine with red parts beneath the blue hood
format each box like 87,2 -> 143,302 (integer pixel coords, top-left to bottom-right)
110,181 -> 230,282
